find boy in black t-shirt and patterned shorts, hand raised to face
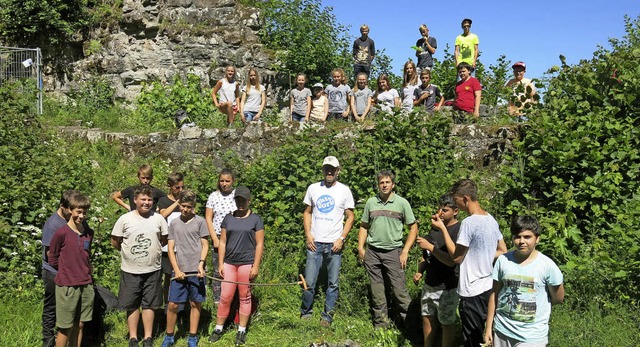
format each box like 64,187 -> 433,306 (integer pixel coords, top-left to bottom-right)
413,194 -> 460,347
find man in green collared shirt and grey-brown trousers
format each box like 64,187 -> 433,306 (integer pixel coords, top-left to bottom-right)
358,170 -> 418,328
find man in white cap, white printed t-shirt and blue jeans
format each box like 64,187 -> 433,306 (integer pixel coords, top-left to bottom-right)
300,156 -> 355,326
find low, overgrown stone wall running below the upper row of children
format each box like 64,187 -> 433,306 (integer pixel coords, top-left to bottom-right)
59,122 -> 520,168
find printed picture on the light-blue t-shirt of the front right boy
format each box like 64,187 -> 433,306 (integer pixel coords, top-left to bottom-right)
498,275 -> 536,322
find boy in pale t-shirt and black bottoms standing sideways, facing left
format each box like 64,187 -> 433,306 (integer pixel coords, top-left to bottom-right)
432,179 -> 507,347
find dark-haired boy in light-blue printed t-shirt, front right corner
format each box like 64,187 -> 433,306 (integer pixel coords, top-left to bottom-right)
484,216 -> 564,347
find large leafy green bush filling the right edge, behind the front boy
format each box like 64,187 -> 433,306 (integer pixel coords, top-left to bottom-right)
505,18 -> 640,303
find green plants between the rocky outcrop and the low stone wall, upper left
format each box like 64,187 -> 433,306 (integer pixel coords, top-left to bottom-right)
43,73 -> 238,134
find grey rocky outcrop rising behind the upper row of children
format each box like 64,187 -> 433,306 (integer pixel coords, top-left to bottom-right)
45,0 -> 275,104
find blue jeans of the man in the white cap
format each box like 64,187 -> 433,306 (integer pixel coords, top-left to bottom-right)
300,242 -> 342,322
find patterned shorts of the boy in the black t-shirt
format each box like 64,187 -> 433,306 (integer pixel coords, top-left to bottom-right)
420,284 -> 460,325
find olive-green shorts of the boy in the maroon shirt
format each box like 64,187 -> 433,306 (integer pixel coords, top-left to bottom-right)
56,284 -> 95,329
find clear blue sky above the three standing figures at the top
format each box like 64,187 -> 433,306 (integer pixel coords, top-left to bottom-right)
322,0 -> 640,78
